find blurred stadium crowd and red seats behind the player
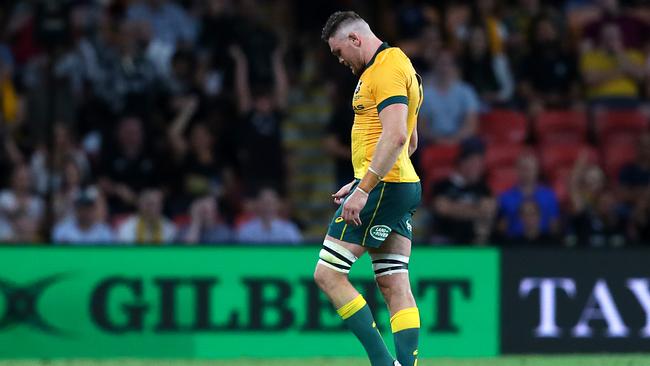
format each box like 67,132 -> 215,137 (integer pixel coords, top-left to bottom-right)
0,0 -> 650,247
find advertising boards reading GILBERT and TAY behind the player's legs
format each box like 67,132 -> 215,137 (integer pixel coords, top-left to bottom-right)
0,246 -> 650,358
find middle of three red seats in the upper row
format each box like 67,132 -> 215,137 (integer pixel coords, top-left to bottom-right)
535,110 -> 587,145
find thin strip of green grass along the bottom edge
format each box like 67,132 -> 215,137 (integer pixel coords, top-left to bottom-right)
0,355 -> 650,366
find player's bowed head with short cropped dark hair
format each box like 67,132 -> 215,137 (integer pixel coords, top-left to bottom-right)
321,11 -> 373,75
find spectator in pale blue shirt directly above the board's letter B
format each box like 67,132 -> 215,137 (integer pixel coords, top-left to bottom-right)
237,188 -> 302,244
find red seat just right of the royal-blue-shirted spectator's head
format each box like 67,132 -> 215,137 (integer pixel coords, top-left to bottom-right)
539,144 -> 598,182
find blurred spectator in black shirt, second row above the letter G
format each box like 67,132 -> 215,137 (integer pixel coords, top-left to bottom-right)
99,117 -> 159,215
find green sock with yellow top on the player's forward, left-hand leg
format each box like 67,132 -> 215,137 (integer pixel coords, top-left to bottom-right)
337,295 -> 393,366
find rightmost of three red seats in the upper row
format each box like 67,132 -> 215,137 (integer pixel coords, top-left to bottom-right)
596,109 -> 648,144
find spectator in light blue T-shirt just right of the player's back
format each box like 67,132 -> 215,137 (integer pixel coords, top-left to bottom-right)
418,51 -> 480,146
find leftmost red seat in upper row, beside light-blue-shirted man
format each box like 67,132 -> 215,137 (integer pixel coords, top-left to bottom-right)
479,109 -> 526,144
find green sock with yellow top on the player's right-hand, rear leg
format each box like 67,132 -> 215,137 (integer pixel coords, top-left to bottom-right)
390,308 -> 420,366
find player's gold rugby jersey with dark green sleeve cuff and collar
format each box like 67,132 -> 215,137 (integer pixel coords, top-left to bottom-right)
352,43 -> 422,183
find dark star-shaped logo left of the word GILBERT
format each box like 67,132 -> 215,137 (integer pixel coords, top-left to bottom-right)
0,274 -> 65,334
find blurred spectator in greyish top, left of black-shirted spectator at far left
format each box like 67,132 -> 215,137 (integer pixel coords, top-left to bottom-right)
30,123 -> 90,194
